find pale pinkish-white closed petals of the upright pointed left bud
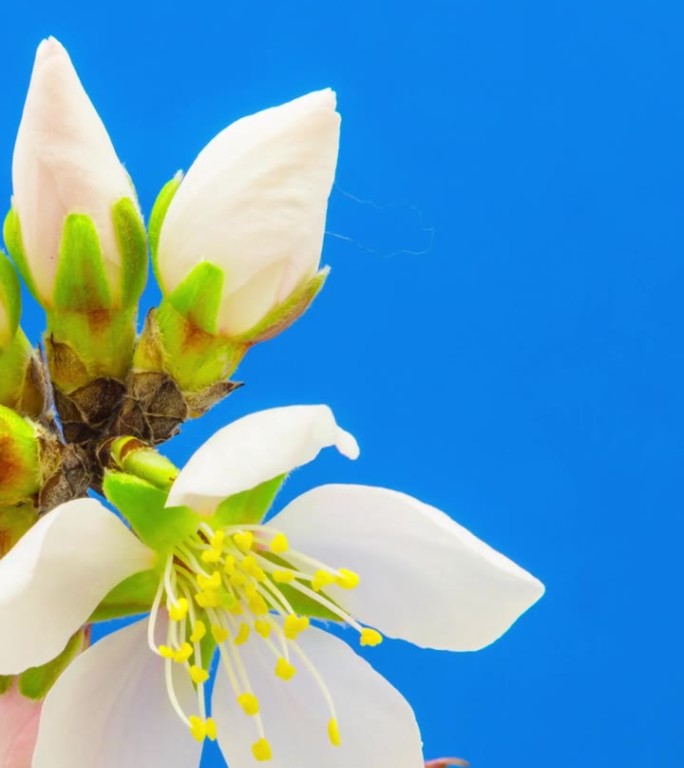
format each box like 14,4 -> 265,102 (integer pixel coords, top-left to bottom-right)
8,37 -> 139,307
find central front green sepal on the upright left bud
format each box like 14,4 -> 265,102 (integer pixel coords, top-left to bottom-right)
53,213 -> 113,313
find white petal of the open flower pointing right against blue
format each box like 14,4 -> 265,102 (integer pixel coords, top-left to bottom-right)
272,485 -> 544,651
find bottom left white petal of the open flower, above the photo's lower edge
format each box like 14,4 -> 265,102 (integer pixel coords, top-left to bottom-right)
33,621 -> 202,768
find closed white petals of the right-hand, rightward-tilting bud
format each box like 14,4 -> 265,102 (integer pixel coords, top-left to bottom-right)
156,89 -> 340,336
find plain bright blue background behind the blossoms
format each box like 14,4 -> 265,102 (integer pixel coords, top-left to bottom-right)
0,0 -> 684,768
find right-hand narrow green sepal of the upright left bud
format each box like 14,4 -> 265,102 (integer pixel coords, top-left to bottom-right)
112,197 -> 147,307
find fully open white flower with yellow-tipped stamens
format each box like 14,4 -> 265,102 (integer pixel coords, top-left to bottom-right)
0,406 -> 543,768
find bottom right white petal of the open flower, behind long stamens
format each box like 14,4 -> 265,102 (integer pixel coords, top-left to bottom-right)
212,628 -> 423,768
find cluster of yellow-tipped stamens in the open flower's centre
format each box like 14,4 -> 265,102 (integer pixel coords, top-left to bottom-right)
148,523 -> 382,761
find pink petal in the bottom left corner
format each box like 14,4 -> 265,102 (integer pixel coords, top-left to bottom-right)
0,685 -> 43,768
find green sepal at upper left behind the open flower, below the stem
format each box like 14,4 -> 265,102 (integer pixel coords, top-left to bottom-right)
103,471 -> 202,553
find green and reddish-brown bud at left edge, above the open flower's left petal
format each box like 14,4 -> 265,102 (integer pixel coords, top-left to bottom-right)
0,405 -> 41,508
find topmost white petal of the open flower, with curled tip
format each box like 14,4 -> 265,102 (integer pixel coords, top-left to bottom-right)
167,405 -> 359,514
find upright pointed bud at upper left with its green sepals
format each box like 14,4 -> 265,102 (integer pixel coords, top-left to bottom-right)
5,38 -> 146,312
